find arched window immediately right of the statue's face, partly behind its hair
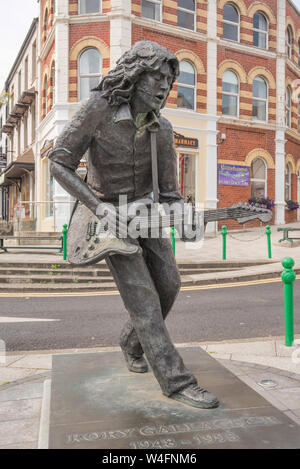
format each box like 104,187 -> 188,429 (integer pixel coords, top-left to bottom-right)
177,60 -> 196,109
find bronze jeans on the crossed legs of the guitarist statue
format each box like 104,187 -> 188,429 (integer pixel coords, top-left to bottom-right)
106,238 -> 197,396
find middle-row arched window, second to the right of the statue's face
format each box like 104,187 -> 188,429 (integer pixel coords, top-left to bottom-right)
222,70 -> 239,117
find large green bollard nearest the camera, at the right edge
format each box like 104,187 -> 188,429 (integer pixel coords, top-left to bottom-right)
281,257 -> 296,347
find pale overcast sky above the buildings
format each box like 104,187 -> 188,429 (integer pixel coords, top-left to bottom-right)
0,0 -> 300,91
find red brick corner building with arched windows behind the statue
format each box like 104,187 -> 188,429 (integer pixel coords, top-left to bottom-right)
12,0 -> 300,230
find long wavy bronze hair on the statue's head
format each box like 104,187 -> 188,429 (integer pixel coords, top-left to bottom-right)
94,41 -> 179,107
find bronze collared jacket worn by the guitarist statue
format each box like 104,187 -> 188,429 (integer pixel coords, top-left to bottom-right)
49,91 -> 182,203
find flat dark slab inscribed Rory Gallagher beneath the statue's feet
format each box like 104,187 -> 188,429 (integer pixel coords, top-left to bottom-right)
49,347 -> 300,449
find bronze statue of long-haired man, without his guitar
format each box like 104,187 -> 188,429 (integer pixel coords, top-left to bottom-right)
50,41 -> 218,408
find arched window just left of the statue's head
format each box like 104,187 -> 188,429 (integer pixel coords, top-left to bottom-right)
78,48 -> 102,101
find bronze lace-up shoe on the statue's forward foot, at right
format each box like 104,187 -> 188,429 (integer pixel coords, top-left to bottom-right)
169,384 -> 219,409
